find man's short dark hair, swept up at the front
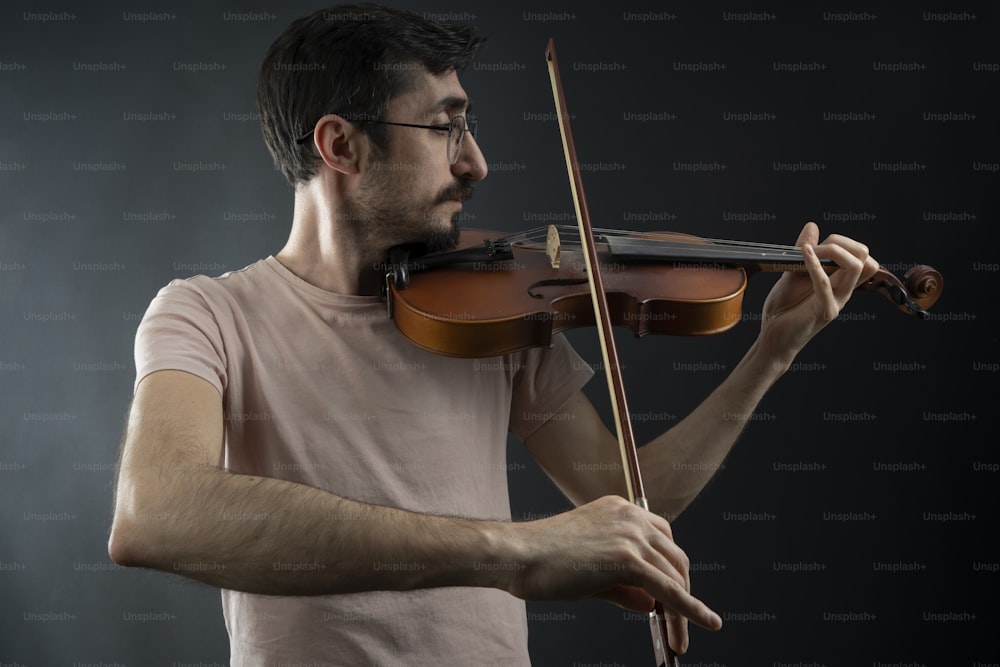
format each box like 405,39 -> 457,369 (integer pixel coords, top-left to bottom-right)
257,4 -> 483,188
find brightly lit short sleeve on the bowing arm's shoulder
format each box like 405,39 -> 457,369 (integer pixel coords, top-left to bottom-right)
135,280 -> 227,394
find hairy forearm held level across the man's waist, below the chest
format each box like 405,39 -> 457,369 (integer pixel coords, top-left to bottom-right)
110,467 -> 509,595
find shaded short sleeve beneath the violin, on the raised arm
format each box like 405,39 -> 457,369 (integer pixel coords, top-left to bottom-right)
510,334 -> 594,440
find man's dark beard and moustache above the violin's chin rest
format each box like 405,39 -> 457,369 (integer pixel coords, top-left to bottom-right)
346,161 -> 475,254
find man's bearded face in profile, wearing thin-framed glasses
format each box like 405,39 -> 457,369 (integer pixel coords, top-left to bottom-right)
353,71 -> 487,250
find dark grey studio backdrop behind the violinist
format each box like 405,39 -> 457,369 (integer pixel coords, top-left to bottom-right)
0,0 -> 1000,667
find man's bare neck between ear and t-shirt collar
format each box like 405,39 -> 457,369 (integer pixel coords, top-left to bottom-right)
275,177 -> 388,295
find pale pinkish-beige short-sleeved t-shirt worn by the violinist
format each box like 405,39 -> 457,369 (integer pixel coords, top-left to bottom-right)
135,257 -> 592,667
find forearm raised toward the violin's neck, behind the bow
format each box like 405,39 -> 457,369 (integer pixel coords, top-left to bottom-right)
639,341 -> 788,520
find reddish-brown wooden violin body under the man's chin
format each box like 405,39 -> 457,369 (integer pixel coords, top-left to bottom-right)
387,229 -> 747,357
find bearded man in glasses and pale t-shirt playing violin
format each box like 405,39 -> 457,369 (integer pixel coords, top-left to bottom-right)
109,5 -> 876,665
